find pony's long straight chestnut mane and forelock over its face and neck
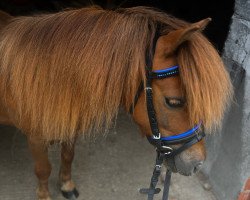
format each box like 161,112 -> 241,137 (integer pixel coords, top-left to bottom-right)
0,7 -> 231,140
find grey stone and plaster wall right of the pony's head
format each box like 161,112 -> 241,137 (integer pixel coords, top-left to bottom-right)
204,0 -> 250,200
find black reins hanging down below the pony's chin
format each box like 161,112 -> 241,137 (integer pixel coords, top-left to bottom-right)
140,151 -> 172,200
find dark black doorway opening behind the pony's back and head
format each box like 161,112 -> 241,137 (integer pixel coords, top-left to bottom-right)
0,0 -> 234,52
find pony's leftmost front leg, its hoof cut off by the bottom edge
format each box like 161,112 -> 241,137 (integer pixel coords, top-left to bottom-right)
28,136 -> 51,200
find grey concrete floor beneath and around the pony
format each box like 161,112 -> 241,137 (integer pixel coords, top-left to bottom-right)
0,114 -> 216,200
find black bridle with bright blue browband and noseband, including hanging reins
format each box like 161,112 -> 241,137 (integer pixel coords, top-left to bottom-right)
134,34 -> 205,200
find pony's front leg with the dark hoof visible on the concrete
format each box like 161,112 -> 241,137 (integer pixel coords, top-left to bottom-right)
59,140 -> 79,199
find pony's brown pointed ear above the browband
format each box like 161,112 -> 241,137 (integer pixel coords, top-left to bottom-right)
155,18 -> 211,56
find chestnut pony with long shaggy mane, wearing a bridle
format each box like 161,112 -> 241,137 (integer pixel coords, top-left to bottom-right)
0,7 -> 232,200
